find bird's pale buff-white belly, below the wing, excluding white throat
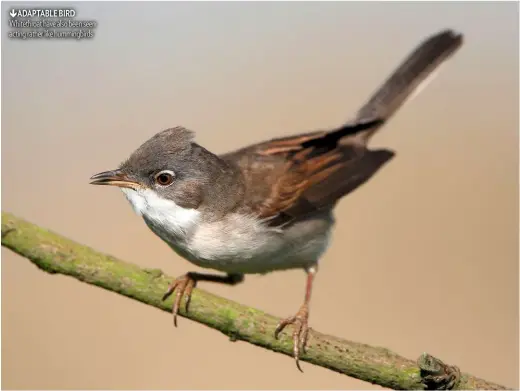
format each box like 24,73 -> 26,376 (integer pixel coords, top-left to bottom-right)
167,216 -> 332,274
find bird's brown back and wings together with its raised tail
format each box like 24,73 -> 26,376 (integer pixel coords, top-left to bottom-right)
219,30 -> 462,225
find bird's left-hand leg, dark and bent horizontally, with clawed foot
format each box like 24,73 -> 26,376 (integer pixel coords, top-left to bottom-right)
163,272 -> 244,327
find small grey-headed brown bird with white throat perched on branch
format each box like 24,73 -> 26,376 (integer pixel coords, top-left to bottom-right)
90,29 -> 463,371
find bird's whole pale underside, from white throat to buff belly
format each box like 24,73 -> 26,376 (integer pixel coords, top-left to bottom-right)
124,189 -> 333,274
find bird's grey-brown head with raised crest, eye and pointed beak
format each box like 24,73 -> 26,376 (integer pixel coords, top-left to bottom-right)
90,127 -> 214,209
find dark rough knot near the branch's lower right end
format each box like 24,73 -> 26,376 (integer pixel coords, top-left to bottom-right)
417,353 -> 460,390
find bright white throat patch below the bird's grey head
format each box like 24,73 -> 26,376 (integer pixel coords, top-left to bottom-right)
121,188 -> 200,243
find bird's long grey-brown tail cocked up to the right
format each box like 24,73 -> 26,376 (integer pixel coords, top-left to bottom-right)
346,30 -> 463,143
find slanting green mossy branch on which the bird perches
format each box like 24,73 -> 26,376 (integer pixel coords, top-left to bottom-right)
2,212 -> 507,390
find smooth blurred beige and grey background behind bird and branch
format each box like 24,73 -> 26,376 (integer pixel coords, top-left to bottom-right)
2,2 -> 519,389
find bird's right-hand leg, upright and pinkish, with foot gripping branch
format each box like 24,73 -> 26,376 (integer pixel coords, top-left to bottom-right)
274,266 -> 318,372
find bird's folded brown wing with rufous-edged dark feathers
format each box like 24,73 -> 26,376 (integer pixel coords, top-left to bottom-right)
250,120 -> 394,225
